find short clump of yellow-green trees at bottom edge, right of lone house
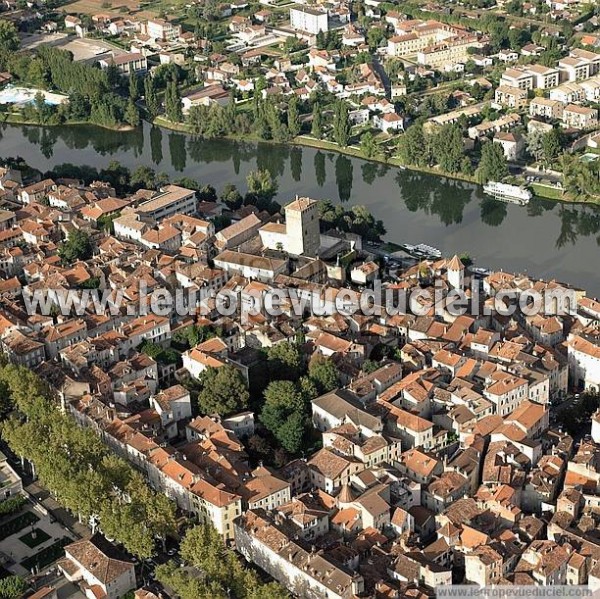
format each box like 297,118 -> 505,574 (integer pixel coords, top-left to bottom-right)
156,525 -> 290,599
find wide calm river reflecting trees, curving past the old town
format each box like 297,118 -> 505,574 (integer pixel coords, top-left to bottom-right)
0,123 -> 600,297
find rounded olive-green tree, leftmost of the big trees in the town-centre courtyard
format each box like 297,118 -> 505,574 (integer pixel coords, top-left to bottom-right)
198,364 -> 250,416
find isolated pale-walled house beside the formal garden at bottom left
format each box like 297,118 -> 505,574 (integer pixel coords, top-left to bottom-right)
58,535 -> 136,599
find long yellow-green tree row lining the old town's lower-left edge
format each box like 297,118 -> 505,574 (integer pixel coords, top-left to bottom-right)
0,365 -> 176,559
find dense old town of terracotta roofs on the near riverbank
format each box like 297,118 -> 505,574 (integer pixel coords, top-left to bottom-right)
0,161 -> 600,599
